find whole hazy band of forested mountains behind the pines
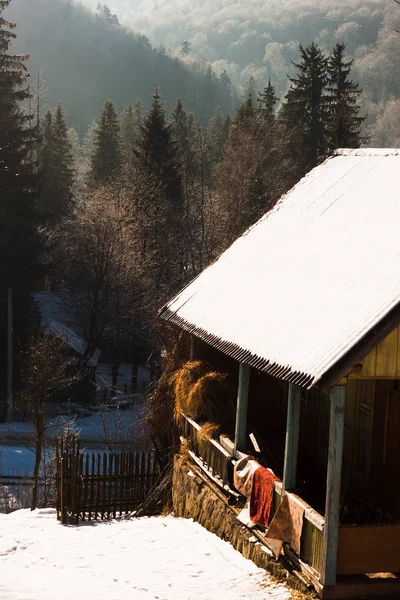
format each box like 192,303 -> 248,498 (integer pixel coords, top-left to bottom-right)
5,0 -> 400,140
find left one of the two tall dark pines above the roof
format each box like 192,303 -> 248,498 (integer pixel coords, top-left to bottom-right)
279,43 -> 328,169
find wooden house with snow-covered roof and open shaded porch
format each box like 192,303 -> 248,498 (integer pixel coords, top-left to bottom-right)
161,149 -> 400,598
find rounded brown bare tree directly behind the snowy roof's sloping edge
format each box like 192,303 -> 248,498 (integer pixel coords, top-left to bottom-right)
214,111 -> 298,251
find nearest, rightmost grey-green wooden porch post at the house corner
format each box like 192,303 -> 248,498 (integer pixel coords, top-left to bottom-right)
322,385 -> 346,585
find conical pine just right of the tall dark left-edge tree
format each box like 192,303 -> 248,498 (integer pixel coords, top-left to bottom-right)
39,103 -> 75,225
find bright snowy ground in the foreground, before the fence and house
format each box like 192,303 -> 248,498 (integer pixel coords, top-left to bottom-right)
0,509 -> 291,600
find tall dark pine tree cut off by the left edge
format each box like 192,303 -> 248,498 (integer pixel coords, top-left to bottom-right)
0,0 -> 42,408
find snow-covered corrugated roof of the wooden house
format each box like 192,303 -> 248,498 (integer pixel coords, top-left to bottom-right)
160,149 -> 400,387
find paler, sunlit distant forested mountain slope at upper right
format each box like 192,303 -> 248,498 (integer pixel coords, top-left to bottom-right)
84,0 -> 400,112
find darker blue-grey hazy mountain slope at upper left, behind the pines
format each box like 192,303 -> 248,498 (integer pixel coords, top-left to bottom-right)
5,0 -> 231,135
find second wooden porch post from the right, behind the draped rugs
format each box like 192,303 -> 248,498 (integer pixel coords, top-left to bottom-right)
282,383 -> 301,494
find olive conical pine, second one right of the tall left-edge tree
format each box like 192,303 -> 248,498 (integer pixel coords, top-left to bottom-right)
89,100 -> 121,185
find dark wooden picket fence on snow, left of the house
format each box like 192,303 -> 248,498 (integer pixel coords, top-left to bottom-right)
56,441 -> 158,523
